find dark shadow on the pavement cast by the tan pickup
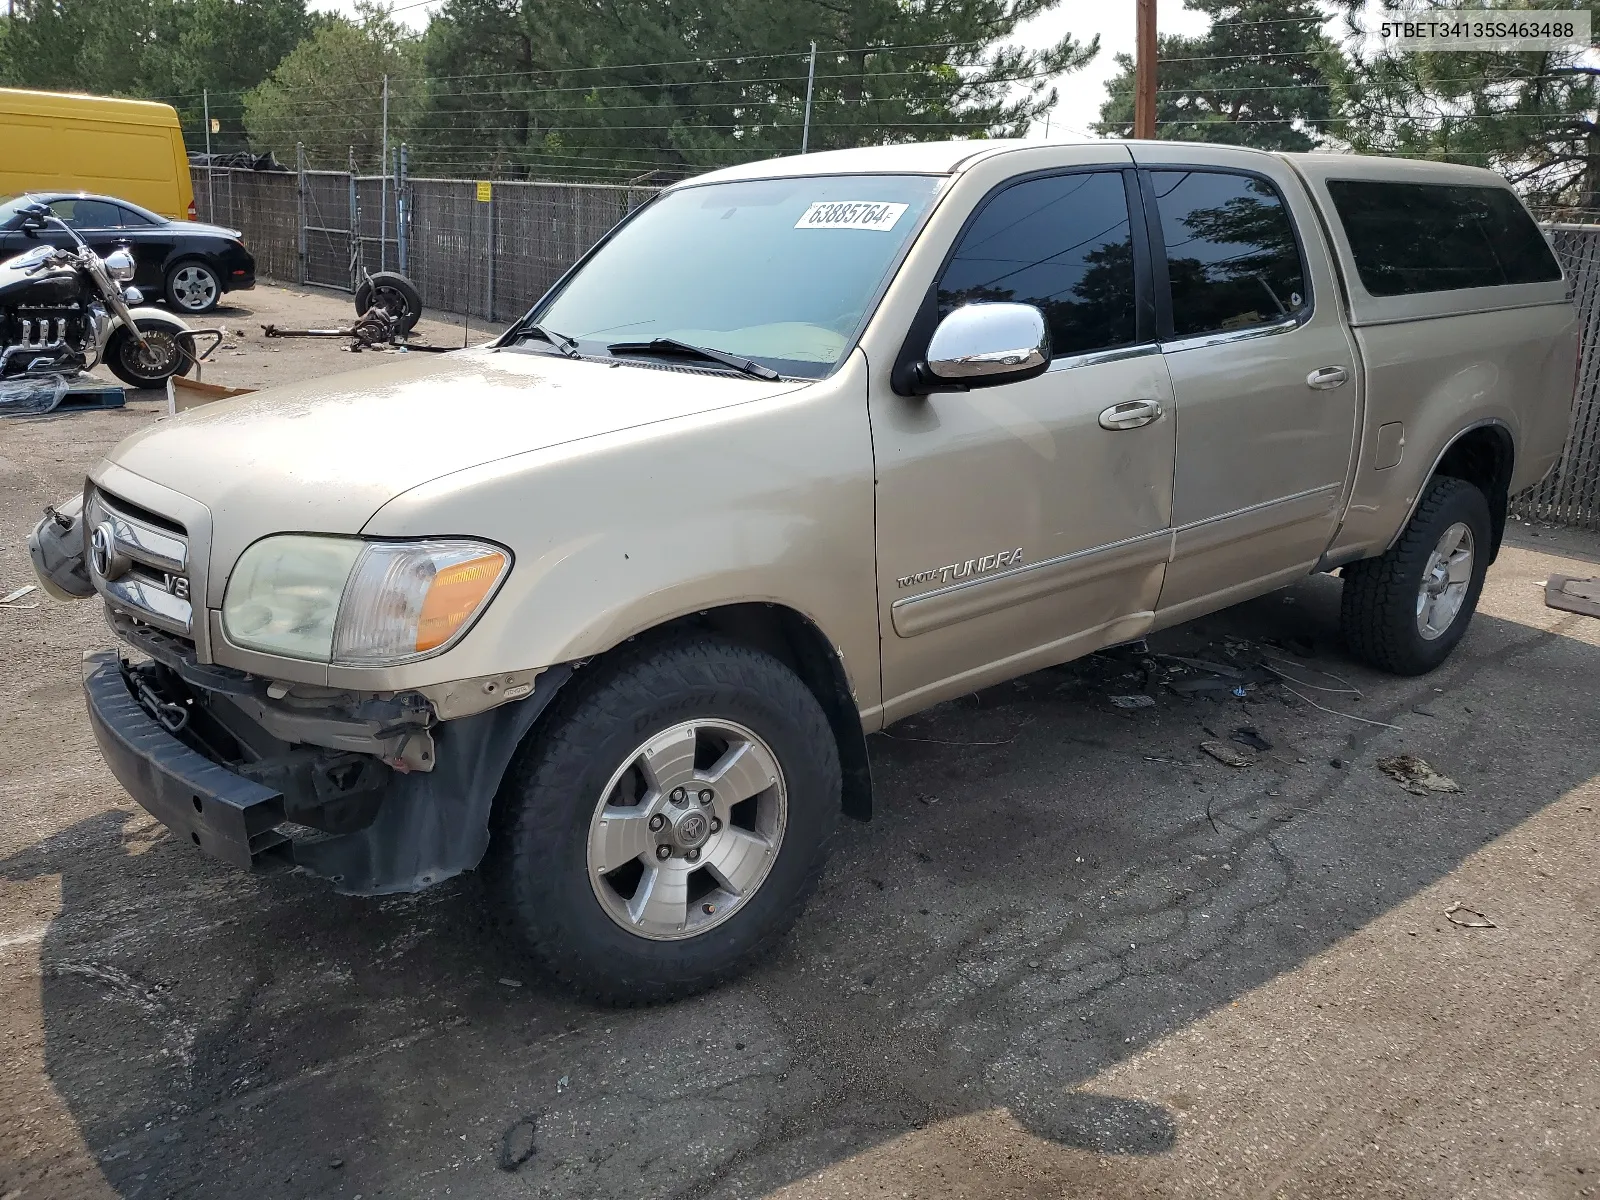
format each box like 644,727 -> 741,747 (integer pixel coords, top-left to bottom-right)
0,578 -> 1600,1197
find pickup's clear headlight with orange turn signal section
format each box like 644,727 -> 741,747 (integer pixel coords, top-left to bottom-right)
222,534 -> 510,667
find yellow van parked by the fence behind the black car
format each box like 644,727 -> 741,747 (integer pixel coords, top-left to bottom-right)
0,88 -> 195,221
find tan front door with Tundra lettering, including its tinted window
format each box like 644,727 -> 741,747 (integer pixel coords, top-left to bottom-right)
872,170 -> 1174,720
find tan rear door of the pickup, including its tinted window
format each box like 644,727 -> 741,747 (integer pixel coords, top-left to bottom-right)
1134,144 -> 1360,619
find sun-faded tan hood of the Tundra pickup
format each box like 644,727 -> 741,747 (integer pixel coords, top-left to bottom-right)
98,347 -> 803,562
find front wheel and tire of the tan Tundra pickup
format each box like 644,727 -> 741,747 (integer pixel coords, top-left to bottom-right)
488,637 -> 840,1003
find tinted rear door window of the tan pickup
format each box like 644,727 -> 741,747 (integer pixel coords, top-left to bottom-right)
1150,171 -> 1306,338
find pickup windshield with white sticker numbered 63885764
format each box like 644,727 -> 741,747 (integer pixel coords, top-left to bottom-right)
533,174 -> 939,378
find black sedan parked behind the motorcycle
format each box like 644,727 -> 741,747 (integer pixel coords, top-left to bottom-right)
0,192 -> 256,315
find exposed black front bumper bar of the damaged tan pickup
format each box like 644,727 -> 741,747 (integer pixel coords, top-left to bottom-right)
83,650 -> 294,870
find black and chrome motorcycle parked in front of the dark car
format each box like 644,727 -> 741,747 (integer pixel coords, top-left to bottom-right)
0,205 -> 203,394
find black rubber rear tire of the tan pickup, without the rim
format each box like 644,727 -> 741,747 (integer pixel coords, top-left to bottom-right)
1341,475 -> 1493,675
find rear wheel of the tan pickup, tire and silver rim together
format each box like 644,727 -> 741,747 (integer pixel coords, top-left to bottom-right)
1341,475 -> 1493,675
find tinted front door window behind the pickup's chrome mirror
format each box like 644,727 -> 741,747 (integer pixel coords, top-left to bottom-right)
939,171 -> 1136,357
